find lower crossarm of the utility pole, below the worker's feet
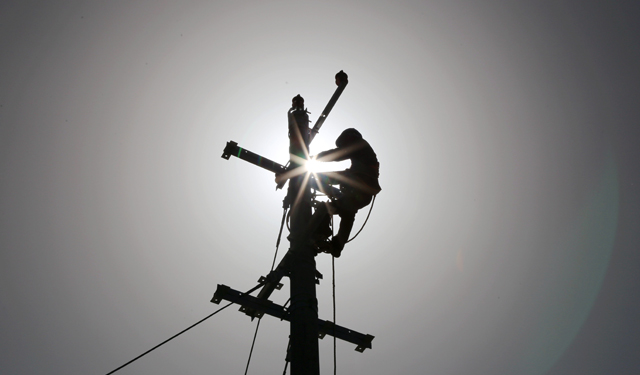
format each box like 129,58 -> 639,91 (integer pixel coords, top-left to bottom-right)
211,284 -> 374,353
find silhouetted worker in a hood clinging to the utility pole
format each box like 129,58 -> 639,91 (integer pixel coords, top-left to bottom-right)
310,129 -> 382,258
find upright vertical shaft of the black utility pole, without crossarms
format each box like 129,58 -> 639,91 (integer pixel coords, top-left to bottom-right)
289,103 -> 320,375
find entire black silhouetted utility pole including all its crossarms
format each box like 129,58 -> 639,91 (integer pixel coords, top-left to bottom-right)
211,71 -> 373,375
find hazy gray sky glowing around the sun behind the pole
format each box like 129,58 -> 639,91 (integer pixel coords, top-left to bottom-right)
0,1 -> 640,375
